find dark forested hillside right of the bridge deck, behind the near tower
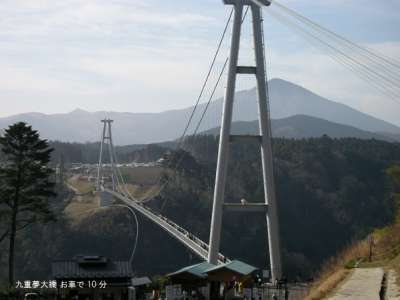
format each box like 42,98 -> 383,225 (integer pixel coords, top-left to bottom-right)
153,137 -> 400,279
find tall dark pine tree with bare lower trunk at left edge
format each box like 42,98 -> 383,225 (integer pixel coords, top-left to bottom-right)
0,122 -> 55,286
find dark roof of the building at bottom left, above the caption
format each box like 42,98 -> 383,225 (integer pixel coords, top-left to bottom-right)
51,256 -> 133,279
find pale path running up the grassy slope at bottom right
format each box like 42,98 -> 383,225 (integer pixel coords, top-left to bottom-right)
329,268 -> 386,300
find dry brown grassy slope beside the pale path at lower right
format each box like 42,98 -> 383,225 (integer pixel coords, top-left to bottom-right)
306,165 -> 400,300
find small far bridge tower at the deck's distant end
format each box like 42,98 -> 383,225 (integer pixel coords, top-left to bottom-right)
96,119 -> 117,191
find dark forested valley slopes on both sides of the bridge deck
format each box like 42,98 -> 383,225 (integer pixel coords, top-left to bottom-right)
0,136 -> 400,280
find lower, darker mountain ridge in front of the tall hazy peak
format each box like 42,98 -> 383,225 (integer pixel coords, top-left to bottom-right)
202,115 -> 400,142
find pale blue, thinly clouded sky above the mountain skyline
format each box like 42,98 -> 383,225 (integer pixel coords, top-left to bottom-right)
0,0 -> 400,125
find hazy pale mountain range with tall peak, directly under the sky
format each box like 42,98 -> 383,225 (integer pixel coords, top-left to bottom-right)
0,79 -> 400,145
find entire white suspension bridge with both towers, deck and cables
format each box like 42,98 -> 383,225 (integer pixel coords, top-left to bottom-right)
92,0 -> 400,282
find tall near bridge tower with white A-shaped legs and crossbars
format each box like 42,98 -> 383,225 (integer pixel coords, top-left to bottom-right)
208,0 -> 282,282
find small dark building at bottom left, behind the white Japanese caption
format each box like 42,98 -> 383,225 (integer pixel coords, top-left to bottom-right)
52,256 -> 133,300
